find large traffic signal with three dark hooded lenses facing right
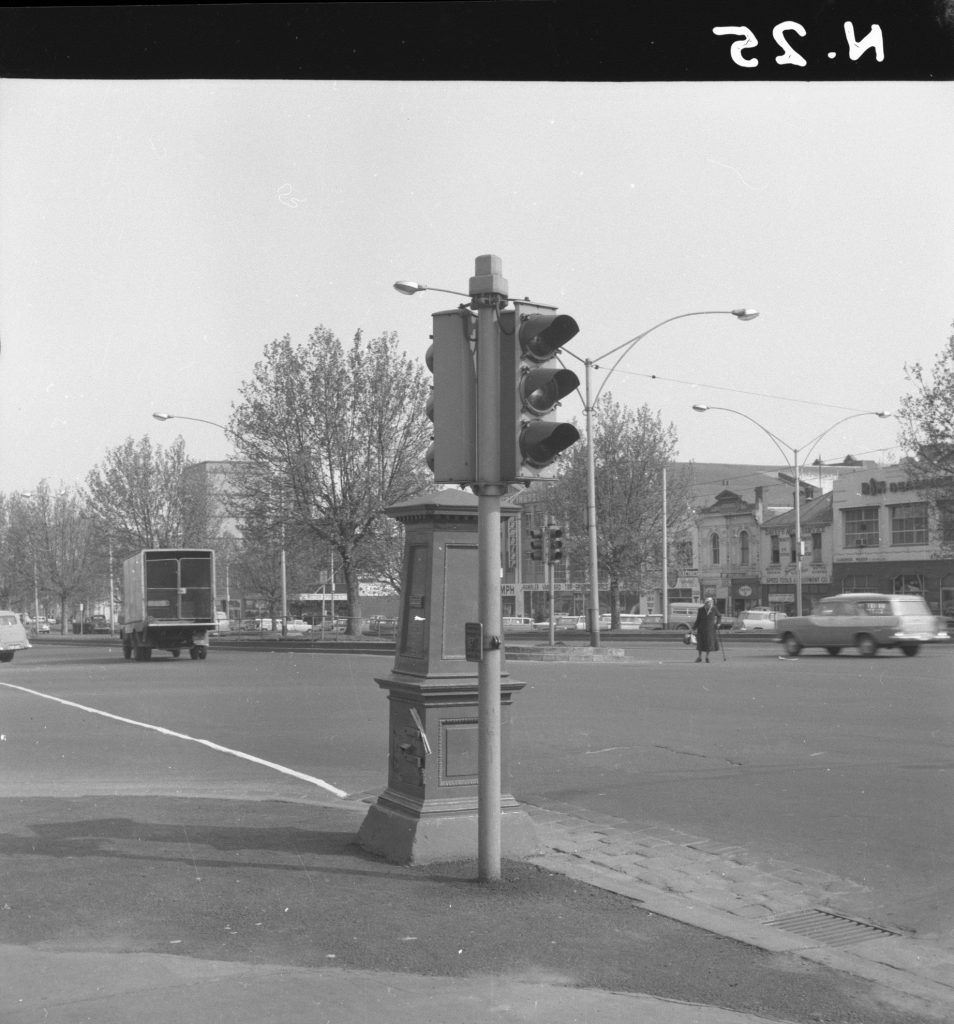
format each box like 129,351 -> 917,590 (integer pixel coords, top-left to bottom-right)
500,300 -> 579,483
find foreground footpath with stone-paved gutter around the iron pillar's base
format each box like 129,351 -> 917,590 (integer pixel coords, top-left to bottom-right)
0,795 -> 954,1024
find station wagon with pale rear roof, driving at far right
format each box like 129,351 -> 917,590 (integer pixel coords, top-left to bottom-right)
778,594 -> 941,657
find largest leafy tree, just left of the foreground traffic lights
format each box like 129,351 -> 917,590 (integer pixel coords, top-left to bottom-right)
229,327 -> 430,628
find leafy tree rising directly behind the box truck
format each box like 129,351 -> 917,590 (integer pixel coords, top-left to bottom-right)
86,436 -> 207,555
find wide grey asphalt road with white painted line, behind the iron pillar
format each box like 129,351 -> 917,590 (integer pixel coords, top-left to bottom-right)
7,638 -> 954,947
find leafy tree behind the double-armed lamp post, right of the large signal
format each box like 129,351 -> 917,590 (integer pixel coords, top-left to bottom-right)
550,392 -> 689,629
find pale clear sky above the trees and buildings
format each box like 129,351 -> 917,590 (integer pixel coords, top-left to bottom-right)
0,79 -> 954,494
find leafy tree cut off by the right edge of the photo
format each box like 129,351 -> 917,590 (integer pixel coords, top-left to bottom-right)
898,325 -> 954,549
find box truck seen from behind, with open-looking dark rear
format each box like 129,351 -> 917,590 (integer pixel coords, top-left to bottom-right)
120,548 -> 215,662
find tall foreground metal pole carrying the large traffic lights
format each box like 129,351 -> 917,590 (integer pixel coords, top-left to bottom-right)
470,256 -> 507,882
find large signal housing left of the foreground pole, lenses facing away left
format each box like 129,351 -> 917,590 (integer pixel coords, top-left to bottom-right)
425,307 -> 477,483
